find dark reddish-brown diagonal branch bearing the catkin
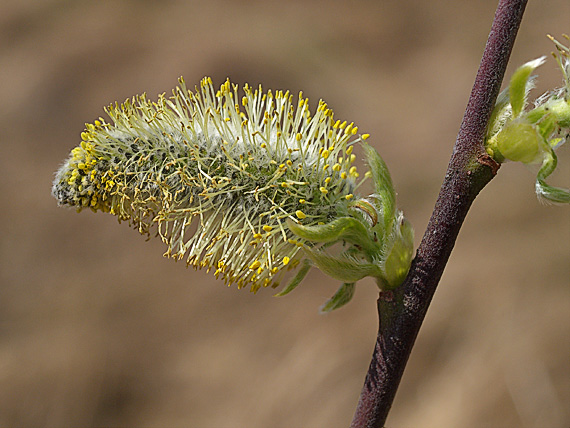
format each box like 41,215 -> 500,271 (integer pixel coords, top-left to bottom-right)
351,0 -> 527,428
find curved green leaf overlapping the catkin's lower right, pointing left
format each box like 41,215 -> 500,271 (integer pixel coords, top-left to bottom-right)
287,217 -> 379,253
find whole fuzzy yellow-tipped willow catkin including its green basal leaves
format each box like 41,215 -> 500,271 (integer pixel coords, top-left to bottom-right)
52,78 -> 413,310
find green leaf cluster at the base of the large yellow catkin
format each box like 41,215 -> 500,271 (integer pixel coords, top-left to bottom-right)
278,143 -> 414,312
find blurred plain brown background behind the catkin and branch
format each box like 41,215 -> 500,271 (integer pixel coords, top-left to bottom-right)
0,0 -> 570,427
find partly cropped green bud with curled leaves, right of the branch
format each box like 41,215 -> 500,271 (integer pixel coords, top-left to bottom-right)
485,39 -> 570,203
